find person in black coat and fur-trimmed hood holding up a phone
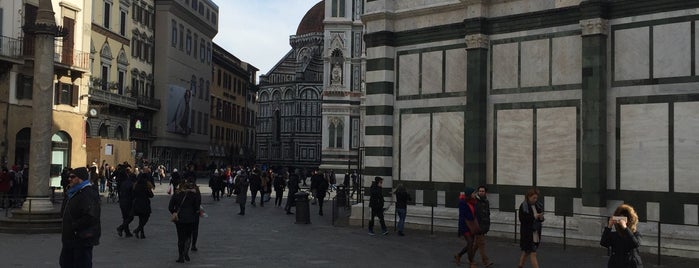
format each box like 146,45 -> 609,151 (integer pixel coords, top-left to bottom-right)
600,204 -> 643,268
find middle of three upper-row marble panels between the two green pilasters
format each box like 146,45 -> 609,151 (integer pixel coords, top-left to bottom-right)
520,39 -> 549,87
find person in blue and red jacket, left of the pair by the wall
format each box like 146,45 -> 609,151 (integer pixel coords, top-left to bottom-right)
454,187 -> 479,268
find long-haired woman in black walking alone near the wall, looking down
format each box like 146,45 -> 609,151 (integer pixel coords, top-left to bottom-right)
518,188 -> 544,268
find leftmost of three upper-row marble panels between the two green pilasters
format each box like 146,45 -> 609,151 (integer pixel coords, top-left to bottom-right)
492,43 -> 519,89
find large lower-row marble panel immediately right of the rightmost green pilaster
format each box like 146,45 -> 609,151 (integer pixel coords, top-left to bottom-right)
619,103 -> 670,192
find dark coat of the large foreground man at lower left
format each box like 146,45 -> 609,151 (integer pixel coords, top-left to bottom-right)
61,185 -> 102,246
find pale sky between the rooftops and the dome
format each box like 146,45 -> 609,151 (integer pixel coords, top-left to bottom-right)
214,0 -> 320,78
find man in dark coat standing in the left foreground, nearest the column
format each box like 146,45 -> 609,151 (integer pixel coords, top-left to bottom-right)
59,167 -> 101,267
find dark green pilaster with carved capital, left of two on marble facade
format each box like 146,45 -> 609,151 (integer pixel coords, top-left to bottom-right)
464,21 -> 489,187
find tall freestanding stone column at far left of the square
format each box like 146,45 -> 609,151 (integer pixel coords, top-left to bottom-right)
22,0 -> 57,212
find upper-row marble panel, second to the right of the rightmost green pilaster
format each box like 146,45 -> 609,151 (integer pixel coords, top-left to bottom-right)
653,22 -> 692,78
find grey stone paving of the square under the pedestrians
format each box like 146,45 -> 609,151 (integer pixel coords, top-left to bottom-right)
0,182 -> 699,268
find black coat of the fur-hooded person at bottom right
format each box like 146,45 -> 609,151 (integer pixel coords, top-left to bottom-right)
600,227 -> 643,268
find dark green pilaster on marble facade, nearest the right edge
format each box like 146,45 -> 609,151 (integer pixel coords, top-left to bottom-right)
580,1 -> 609,207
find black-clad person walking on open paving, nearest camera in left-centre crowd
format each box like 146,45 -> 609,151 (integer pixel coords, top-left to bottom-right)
168,183 -> 201,263
